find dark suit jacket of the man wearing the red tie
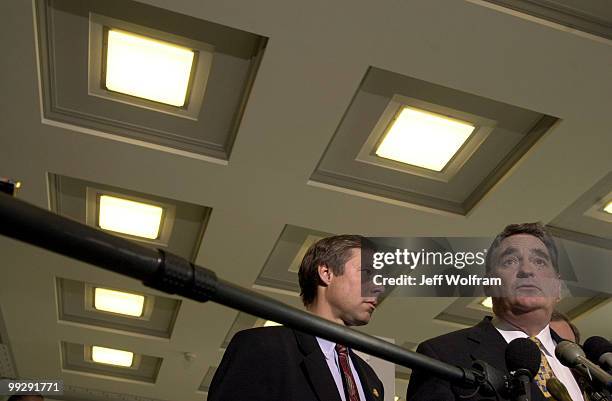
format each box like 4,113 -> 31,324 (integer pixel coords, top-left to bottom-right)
208,327 -> 384,401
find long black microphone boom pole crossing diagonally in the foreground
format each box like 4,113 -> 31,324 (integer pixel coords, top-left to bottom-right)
0,193 -> 486,387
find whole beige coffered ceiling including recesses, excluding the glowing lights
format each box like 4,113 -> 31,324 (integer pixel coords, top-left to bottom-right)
0,0 -> 612,401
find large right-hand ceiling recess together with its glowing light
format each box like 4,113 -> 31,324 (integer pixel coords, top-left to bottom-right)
308,66 -> 558,215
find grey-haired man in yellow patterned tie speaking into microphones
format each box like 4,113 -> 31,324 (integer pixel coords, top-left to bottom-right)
406,223 -> 583,401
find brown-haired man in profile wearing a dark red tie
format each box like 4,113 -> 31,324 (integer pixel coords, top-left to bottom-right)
208,235 -> 384,401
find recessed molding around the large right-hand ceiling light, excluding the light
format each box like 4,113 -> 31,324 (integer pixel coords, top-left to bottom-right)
309,67 -> 559,216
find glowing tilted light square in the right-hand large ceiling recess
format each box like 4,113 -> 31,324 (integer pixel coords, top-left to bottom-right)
376,107 -> 475,171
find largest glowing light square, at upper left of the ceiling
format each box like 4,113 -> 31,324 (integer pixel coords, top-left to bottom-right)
106,29 -> 195,107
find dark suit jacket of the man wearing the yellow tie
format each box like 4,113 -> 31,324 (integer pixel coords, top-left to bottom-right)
406,316 -> 561,401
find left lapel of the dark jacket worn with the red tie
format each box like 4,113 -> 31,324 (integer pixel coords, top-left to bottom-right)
293,330 -> 342,401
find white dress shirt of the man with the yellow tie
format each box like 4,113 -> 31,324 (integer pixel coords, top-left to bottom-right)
493,317 -> 584,401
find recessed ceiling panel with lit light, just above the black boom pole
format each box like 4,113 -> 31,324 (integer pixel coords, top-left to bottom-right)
48,173 -> 212,261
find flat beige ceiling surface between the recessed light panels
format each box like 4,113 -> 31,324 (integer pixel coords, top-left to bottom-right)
0,0 -> 612,401
